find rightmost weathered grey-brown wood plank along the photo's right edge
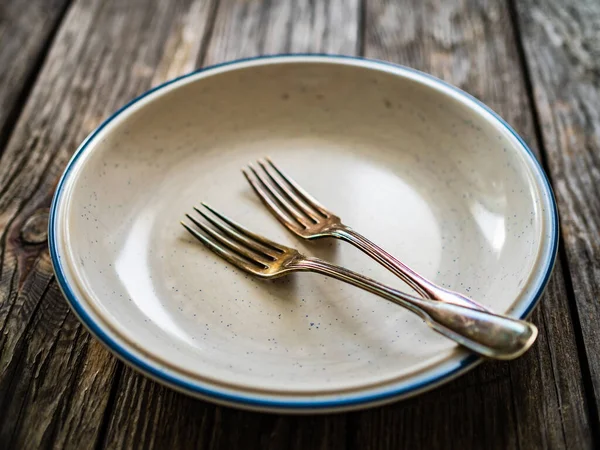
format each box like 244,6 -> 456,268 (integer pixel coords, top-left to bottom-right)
516,0 -> 600,427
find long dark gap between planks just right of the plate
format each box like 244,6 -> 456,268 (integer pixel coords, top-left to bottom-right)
507,0 -> 600,442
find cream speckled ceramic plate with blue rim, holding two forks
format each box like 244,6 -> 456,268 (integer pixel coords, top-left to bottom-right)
50,55 -> 557,412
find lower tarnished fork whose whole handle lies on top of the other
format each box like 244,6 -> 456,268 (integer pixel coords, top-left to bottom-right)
181,203 -> 538,359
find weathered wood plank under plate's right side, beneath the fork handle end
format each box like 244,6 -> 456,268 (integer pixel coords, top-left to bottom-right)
342,0 -> 592,449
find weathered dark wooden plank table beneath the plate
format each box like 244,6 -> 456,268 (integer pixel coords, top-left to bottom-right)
0,0 -> 600,450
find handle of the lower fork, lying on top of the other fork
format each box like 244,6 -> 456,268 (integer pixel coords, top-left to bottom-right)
293,258 -> 538,359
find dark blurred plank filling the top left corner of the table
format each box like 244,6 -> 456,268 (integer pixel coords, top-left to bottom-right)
0,0 -> 70,154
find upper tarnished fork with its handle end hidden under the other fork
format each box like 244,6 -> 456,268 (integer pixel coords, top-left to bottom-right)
242,158 -> 489,311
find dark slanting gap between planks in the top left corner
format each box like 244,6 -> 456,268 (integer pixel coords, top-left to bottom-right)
0,0 -> 73,157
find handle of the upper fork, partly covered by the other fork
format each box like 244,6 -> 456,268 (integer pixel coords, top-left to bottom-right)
333,225 -> 489,311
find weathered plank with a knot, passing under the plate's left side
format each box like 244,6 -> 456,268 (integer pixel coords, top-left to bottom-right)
0,0 -> 212,448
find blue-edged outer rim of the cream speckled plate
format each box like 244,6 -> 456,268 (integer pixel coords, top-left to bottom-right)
48,53 -> 559,412
